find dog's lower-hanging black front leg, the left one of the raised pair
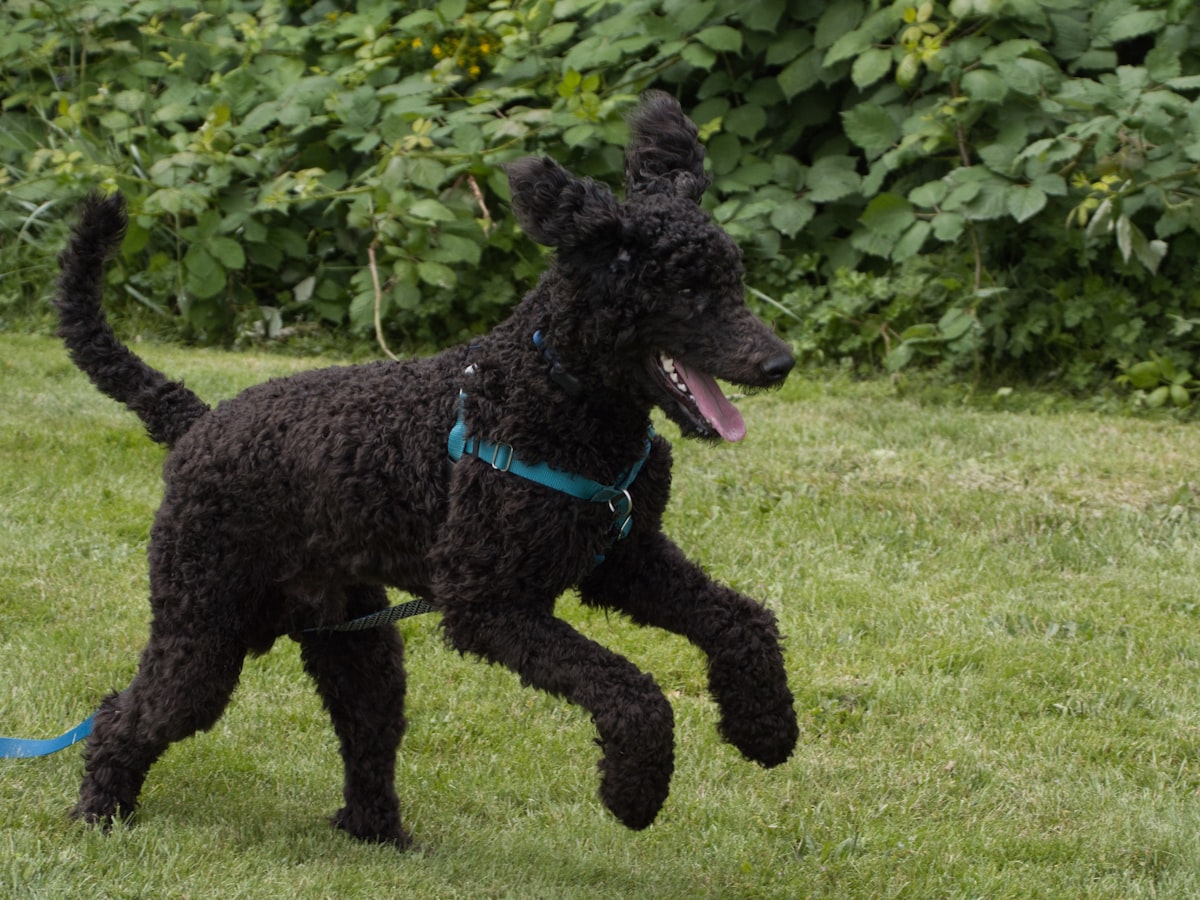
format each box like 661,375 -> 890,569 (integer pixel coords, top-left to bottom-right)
442,596 -> 674,829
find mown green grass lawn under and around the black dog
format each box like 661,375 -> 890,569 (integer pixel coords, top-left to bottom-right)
0,335 -> 1200,898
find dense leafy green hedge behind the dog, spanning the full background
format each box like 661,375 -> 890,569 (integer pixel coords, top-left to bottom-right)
7,0 -> 1200,393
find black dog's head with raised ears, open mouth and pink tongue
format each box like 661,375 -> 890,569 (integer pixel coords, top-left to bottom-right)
509,91 -> 793,440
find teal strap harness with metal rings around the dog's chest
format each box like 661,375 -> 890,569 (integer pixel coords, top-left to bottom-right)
446,390 -> 654,556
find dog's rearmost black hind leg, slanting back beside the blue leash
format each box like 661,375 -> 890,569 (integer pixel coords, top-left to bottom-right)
72,604 -> 246,827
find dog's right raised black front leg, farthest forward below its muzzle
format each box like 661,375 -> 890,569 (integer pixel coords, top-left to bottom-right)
581,532 -> 799,767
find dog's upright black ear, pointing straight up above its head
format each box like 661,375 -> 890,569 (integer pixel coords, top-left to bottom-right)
625,91 -> 710,203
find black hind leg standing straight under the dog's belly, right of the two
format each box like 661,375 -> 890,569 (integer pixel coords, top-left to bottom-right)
300,587 -> 412,848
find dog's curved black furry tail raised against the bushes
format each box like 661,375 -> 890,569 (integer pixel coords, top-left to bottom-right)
54,193 -> 209,446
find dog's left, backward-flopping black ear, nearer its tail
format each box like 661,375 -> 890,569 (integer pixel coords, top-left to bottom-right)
508,156 -> 622,252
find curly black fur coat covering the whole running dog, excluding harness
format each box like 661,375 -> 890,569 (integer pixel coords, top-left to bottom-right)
56,94 -> 797,846
